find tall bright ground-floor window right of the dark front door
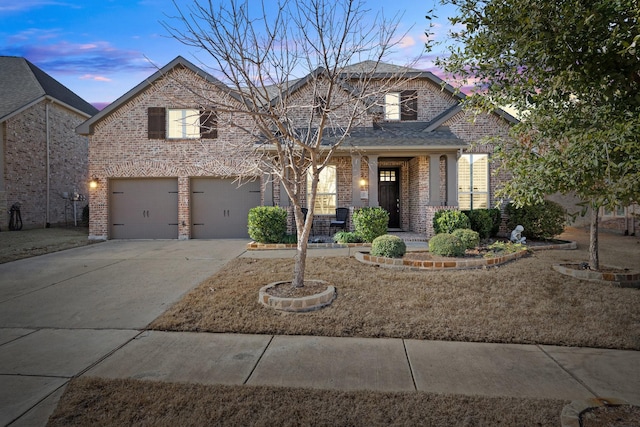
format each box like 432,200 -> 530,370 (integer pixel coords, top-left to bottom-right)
458,154 -> 489,210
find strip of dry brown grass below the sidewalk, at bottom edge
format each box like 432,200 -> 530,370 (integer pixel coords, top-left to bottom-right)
48,378 -> 568,427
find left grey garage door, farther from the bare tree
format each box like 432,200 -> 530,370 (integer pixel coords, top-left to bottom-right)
110,178 -> 178,239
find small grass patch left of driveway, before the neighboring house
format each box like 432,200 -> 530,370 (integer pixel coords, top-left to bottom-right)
0,227 -> 95,264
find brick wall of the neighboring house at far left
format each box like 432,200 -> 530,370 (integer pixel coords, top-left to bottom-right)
0,101 -> 88,229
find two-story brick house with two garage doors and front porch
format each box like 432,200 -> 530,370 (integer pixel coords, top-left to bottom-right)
77,57 -> 515,239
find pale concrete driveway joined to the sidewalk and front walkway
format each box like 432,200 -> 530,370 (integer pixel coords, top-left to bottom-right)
0,240 -> 640,426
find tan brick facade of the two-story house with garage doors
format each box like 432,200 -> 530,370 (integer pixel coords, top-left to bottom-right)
89,59 -> 509,239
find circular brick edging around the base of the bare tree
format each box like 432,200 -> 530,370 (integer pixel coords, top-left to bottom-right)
258,280 -> 336,312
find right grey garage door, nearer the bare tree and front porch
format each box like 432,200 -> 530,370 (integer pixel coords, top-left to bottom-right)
191,178 -> 260,239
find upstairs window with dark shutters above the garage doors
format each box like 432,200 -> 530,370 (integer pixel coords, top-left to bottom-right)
147,107 -> 218,139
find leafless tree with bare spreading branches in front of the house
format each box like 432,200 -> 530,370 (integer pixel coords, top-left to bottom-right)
163,0 -> 416,287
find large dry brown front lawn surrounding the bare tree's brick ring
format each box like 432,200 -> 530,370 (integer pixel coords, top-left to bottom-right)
150,230 -> 640,350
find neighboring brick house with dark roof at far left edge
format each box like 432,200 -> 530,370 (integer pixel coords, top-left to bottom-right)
0,56 -> 98,231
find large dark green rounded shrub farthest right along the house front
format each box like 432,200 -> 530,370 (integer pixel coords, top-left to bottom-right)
505,200 -> 566,240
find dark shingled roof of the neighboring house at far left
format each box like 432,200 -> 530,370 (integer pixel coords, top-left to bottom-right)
0,56 -> 98,121
